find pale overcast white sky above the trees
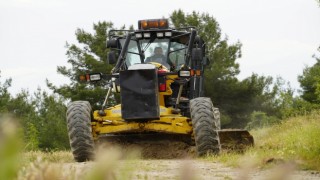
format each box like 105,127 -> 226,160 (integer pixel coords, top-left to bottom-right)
0,0 -> 320,94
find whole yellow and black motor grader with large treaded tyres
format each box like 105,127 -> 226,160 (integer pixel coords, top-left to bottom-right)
67,19 -> 253,162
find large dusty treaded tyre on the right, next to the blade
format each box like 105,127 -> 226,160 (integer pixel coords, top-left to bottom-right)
190,97 -> 221,156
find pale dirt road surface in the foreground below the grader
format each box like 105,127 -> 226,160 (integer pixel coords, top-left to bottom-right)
64,159 -> 320,180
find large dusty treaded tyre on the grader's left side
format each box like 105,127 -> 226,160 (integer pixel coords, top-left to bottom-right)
67,101 -> 94,162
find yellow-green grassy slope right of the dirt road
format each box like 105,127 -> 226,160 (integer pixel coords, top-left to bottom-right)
206,111 -> 320,171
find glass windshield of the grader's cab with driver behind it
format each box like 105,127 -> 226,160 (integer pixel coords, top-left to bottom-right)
120,38 -> 186,70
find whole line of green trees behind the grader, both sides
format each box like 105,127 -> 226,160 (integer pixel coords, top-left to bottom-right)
0,10 -> 320,150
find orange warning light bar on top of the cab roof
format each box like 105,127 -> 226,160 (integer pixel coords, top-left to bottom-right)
138,19 -> 169,30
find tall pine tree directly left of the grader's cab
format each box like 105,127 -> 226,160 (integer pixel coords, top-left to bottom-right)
47,22 -> 113,107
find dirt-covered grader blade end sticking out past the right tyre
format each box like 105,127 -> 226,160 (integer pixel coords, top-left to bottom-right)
218,129 -> 254,151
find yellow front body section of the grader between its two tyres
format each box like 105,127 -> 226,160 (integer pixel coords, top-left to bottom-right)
91,105 -> 192,139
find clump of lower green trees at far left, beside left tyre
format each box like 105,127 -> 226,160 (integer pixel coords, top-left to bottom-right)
0,71 -> 69,150
